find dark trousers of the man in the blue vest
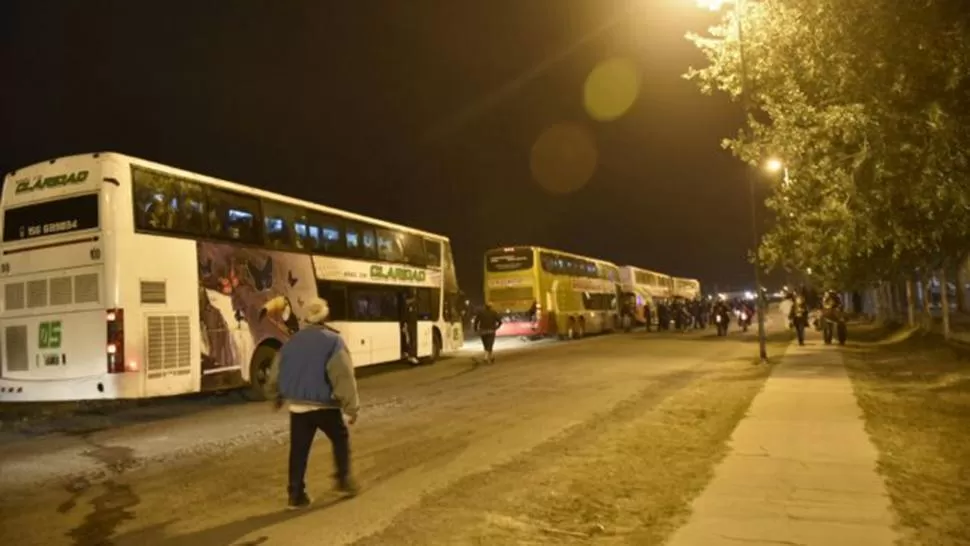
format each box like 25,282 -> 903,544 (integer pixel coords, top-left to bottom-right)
288,409 -> 350,495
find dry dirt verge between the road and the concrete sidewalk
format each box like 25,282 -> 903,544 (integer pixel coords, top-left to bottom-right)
355,342 -> 787,546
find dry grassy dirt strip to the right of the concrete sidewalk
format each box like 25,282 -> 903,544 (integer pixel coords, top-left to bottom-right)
845,326 -> 970,545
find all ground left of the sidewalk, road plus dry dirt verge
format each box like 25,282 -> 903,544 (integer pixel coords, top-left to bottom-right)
0,326 -> 776,546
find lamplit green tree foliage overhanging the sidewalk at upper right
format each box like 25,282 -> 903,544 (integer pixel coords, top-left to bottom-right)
686,0 -> 970,287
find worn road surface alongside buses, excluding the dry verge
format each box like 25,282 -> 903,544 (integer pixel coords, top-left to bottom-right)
0,326 -> 772,546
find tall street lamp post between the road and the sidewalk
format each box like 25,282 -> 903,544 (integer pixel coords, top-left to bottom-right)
697,0 -> 764,363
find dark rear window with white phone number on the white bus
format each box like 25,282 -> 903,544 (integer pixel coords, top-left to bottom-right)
3,193 -> 99,243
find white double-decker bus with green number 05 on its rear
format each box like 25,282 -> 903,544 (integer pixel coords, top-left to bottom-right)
0,153 -> 463,401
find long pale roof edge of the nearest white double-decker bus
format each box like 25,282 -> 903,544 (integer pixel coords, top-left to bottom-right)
5,152 -> 449,241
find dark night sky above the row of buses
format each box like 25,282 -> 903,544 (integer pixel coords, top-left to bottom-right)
0,0 -> 772,295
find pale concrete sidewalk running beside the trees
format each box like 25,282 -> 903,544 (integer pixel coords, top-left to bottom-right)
667,336 -> 897,546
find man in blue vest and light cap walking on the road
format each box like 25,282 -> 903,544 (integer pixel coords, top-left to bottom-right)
276,298 -> 360,509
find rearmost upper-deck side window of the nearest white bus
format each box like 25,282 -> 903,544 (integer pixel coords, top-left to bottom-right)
131,166 -> 207,235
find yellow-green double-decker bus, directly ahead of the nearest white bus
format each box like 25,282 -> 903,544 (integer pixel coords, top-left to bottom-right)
484,246 -> 621,339
